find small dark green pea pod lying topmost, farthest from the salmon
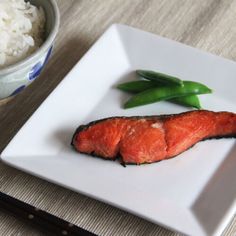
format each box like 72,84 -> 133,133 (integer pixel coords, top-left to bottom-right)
136,70 -> 183,86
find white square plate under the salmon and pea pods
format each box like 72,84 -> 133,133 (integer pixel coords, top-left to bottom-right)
1,25 -> 236,236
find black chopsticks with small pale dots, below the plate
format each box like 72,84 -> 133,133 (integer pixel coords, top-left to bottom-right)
0,192 -> 95,236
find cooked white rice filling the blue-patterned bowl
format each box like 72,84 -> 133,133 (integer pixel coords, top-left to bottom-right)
0,0 -> 45,68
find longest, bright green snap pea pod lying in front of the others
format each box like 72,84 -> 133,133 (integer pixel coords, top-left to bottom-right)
124,81 -> 212,108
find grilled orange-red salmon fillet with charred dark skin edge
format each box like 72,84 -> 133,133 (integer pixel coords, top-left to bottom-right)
71,110 -> 236,164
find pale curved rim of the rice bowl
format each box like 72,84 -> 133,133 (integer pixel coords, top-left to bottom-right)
0,0 -> 60,75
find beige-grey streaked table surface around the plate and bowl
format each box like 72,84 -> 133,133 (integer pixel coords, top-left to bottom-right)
0,0 -> 236,236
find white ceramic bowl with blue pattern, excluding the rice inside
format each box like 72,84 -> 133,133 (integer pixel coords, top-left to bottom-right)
0,0 -> 60,99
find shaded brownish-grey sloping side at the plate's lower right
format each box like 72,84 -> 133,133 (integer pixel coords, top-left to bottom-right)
191,144 -> 236,235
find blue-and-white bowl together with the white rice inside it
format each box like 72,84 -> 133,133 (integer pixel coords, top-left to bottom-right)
0,0 -> 60,100
